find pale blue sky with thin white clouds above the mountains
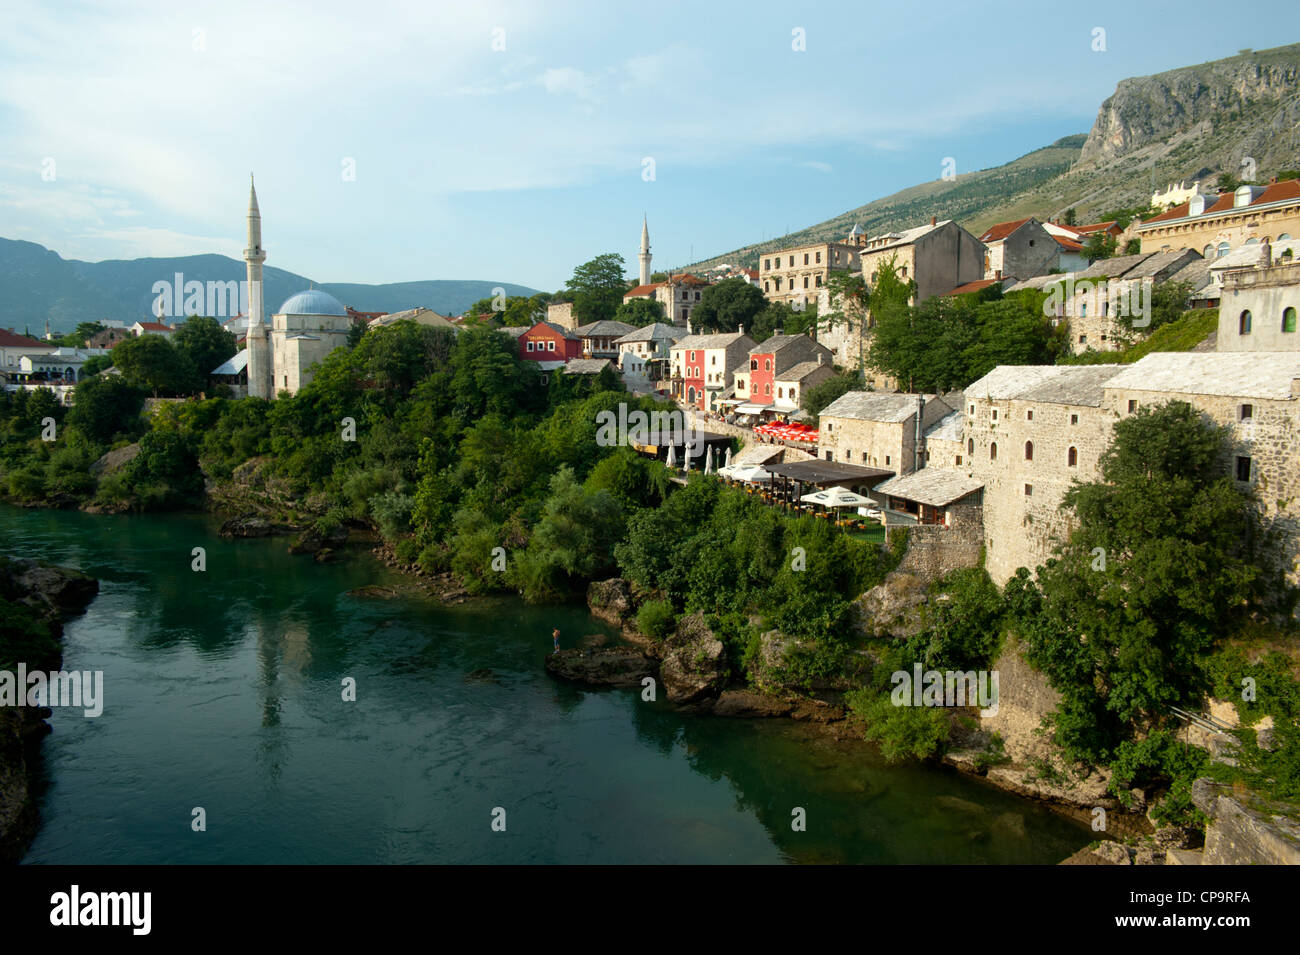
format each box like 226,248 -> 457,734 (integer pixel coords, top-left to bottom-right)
0,0 -> 1300,291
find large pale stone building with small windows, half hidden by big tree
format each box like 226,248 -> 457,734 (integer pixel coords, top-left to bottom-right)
966,352 -> 1300,583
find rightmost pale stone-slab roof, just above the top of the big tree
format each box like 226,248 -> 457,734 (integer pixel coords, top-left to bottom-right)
1106,352 -> 1300,400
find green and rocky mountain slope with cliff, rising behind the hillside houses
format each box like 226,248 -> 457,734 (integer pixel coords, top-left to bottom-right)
684,44 -> 1300,269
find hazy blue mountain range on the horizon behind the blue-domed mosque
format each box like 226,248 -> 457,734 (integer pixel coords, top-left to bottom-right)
0,239 -> 537,334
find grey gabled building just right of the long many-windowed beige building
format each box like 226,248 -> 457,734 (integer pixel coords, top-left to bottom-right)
859,216 -> 984,305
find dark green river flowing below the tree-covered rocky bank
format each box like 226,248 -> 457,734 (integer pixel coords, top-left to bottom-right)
0,508 -> 1092,864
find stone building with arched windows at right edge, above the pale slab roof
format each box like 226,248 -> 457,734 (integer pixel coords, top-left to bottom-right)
1216,243 -> 1300,353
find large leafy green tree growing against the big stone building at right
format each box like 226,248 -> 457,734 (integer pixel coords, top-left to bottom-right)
1006,401 -> 1264,761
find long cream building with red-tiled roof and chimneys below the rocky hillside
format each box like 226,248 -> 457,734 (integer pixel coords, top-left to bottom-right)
1136,179 -> 1300,259
